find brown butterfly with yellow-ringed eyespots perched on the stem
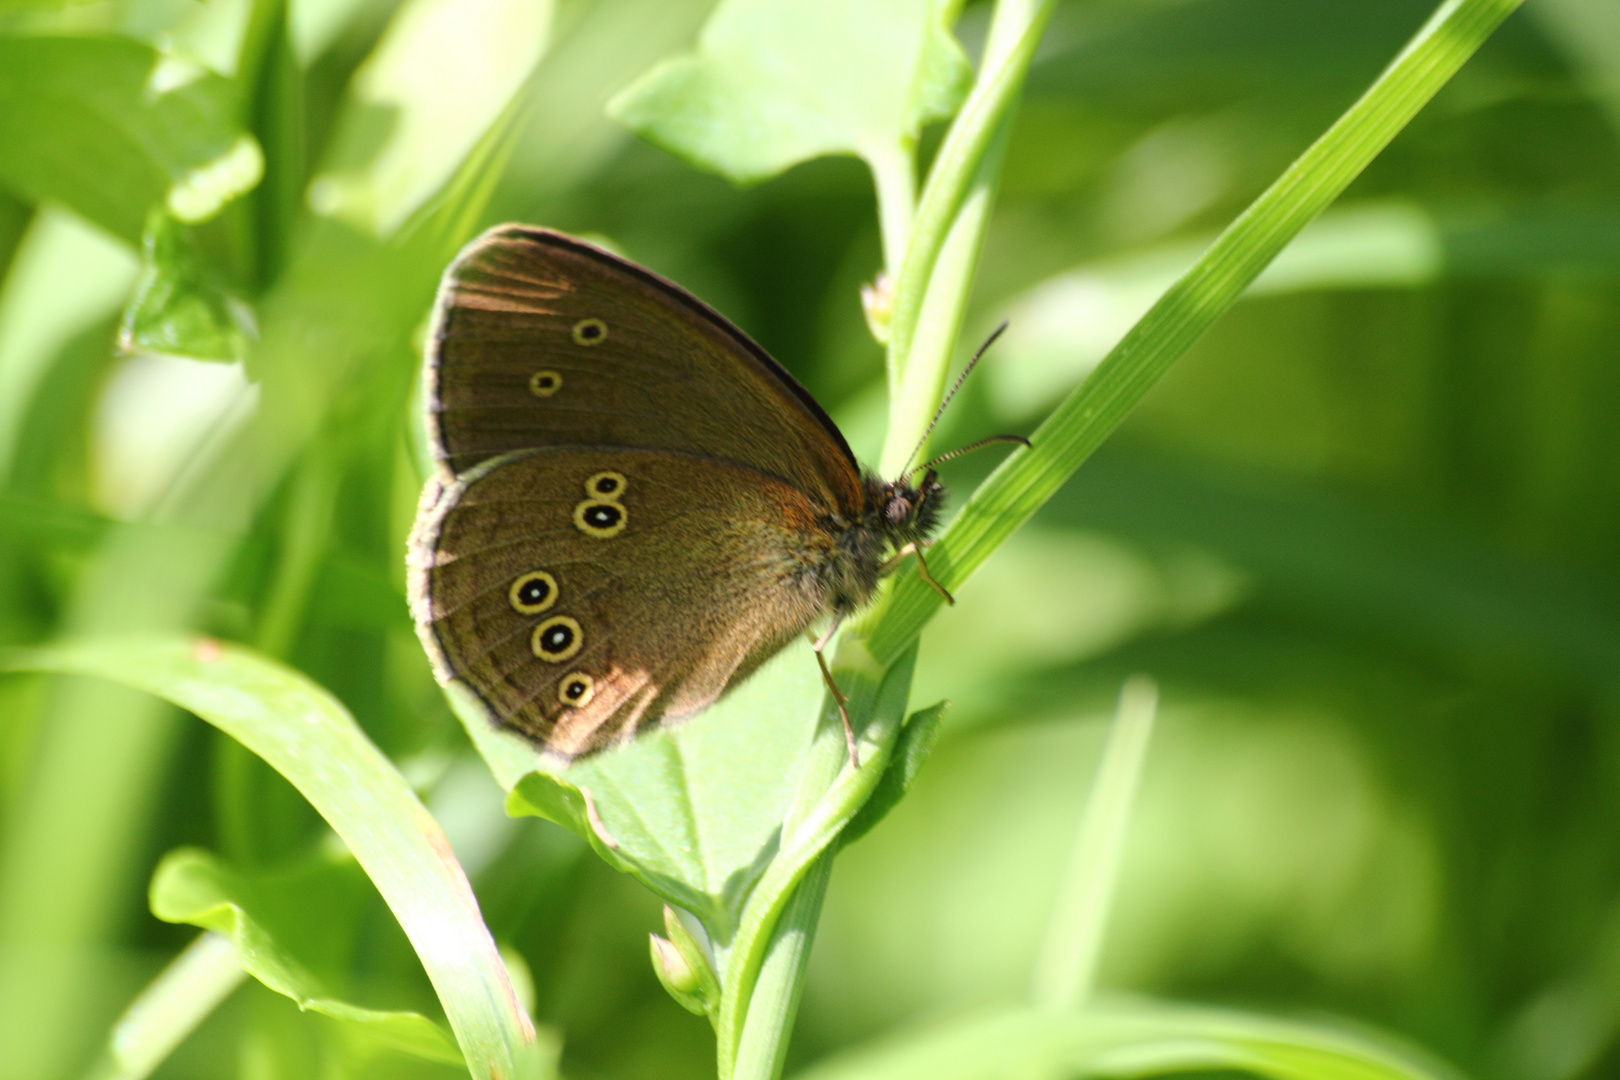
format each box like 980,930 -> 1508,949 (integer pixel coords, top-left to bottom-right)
410,225 -> 1010,758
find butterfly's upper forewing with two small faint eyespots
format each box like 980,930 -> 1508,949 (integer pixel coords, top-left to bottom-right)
428,225 -> 863,512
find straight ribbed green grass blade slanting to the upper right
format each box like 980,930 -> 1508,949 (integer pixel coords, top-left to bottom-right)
863,0 -> 1521,664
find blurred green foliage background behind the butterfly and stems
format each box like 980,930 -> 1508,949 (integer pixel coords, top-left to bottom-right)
0,0 -> 1620,1080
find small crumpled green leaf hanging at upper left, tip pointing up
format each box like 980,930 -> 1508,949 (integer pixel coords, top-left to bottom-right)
118,209 -> 253,361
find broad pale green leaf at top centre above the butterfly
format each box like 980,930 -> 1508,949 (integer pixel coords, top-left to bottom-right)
609,0 -> 969,183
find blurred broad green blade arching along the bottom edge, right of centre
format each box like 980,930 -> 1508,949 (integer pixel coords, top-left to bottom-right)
797,1004 -> 1447,1080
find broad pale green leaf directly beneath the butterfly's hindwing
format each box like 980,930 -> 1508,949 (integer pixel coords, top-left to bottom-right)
479,643 -> 933,1075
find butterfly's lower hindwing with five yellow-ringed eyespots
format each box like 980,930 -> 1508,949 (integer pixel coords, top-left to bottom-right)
411,447 -> 833,758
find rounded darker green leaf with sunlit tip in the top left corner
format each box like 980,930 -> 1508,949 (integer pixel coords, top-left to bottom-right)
0,37 -> 264,243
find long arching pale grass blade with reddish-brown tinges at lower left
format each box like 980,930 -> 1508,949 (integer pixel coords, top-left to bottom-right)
0,638 -> 548,1078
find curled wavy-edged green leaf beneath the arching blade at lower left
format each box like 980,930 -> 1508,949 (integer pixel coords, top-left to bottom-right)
151,848 -> 462,1065
